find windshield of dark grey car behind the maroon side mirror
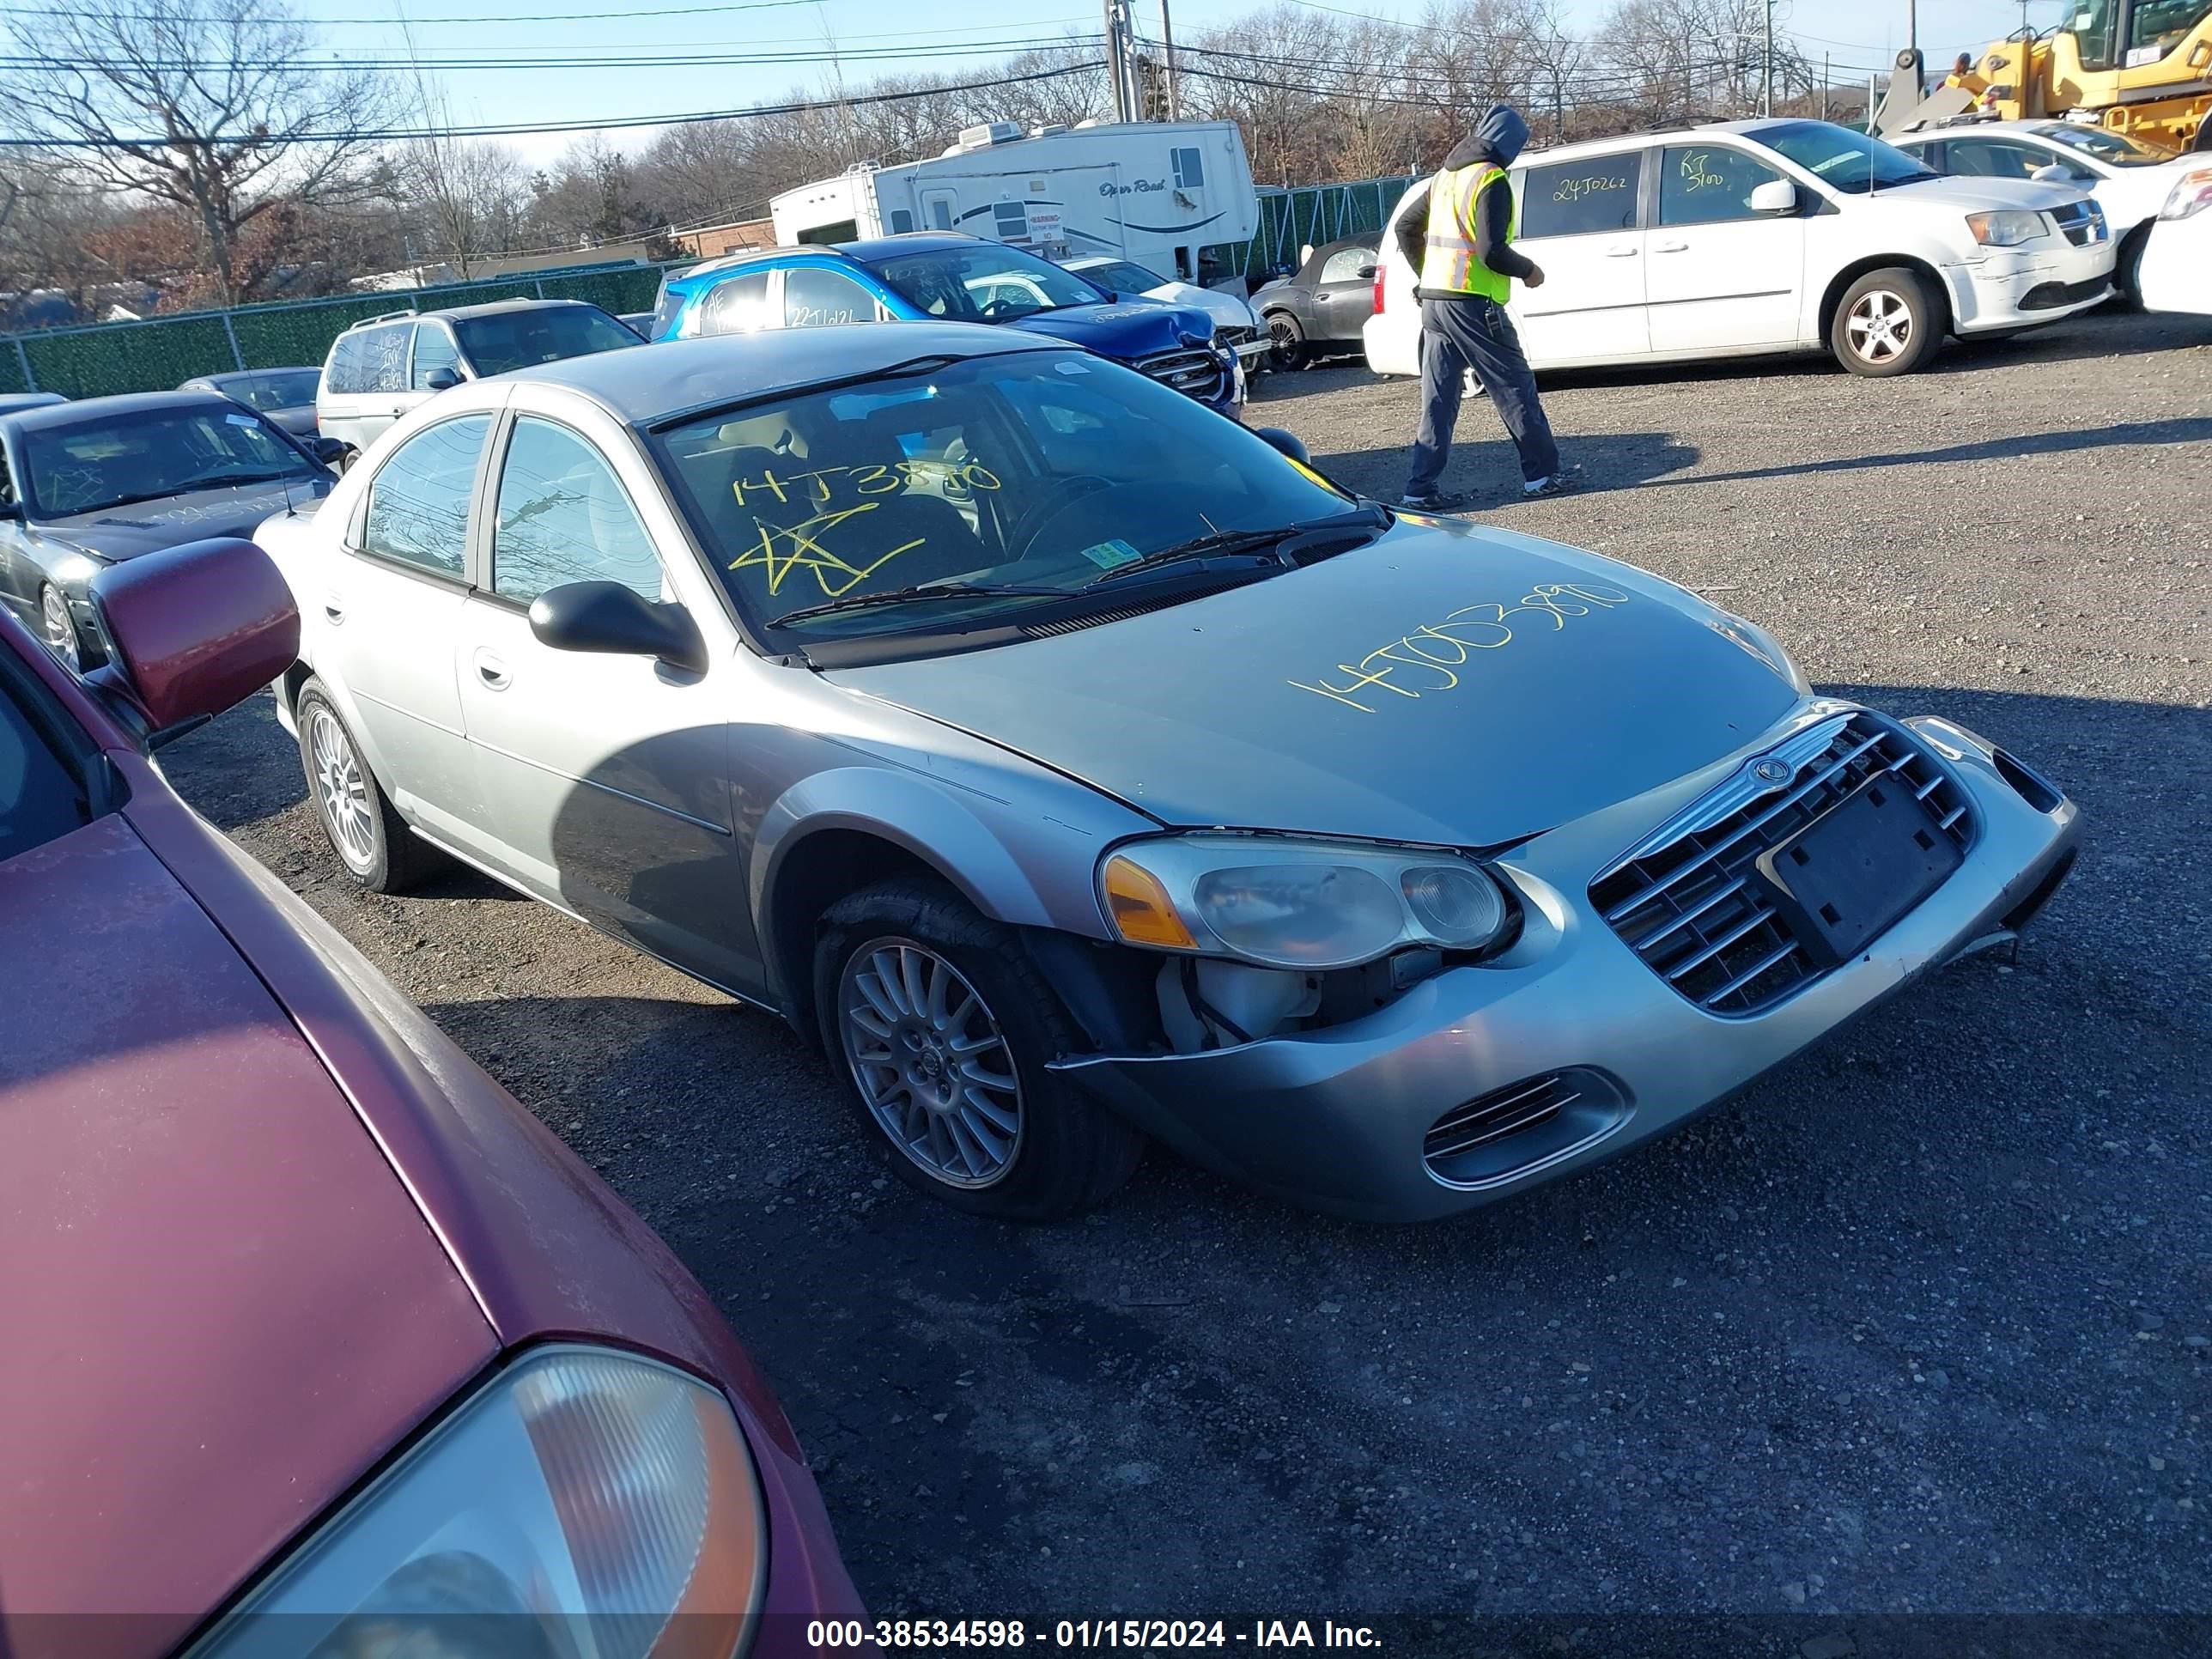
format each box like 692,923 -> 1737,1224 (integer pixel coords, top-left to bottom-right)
22,398 -> 325,518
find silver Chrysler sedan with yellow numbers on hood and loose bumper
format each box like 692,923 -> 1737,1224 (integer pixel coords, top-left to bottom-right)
251,323 -> 2075,1218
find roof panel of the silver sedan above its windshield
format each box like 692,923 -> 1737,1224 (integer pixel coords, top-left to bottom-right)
500,323 -> 1078,427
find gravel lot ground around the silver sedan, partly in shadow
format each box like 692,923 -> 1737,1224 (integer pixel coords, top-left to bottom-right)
166,319 -> 2212,1652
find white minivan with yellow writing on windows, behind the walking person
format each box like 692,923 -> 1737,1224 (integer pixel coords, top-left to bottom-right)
1364,119 -> 2112,374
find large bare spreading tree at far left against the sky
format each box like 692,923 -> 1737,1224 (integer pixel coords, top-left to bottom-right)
0,0 -> 387,303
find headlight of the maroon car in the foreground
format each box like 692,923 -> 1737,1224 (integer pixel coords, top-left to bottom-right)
192,1347 -> 768,1659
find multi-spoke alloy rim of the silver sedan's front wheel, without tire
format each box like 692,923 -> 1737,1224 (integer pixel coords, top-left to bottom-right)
838,938 -> 1022,1188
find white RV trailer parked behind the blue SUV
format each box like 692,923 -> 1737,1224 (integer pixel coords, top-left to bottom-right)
768,122 -> 1259,281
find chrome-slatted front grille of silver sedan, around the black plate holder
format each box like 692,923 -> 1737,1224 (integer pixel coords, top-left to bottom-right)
1590,714 -> 1973,1015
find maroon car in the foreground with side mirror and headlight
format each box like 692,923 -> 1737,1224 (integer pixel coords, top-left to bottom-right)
0,542 -> 860,1659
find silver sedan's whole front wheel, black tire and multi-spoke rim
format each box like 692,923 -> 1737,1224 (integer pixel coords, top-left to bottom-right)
814,880 -> 1144,1221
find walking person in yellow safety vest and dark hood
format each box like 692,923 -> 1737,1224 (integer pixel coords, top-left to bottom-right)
1391,104 -> 1571,511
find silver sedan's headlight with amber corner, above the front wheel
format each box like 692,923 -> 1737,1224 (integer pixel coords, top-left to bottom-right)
1099,834 -> 1513,971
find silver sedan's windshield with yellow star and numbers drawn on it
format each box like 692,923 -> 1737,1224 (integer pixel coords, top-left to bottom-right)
657,352 -> 1354,637
